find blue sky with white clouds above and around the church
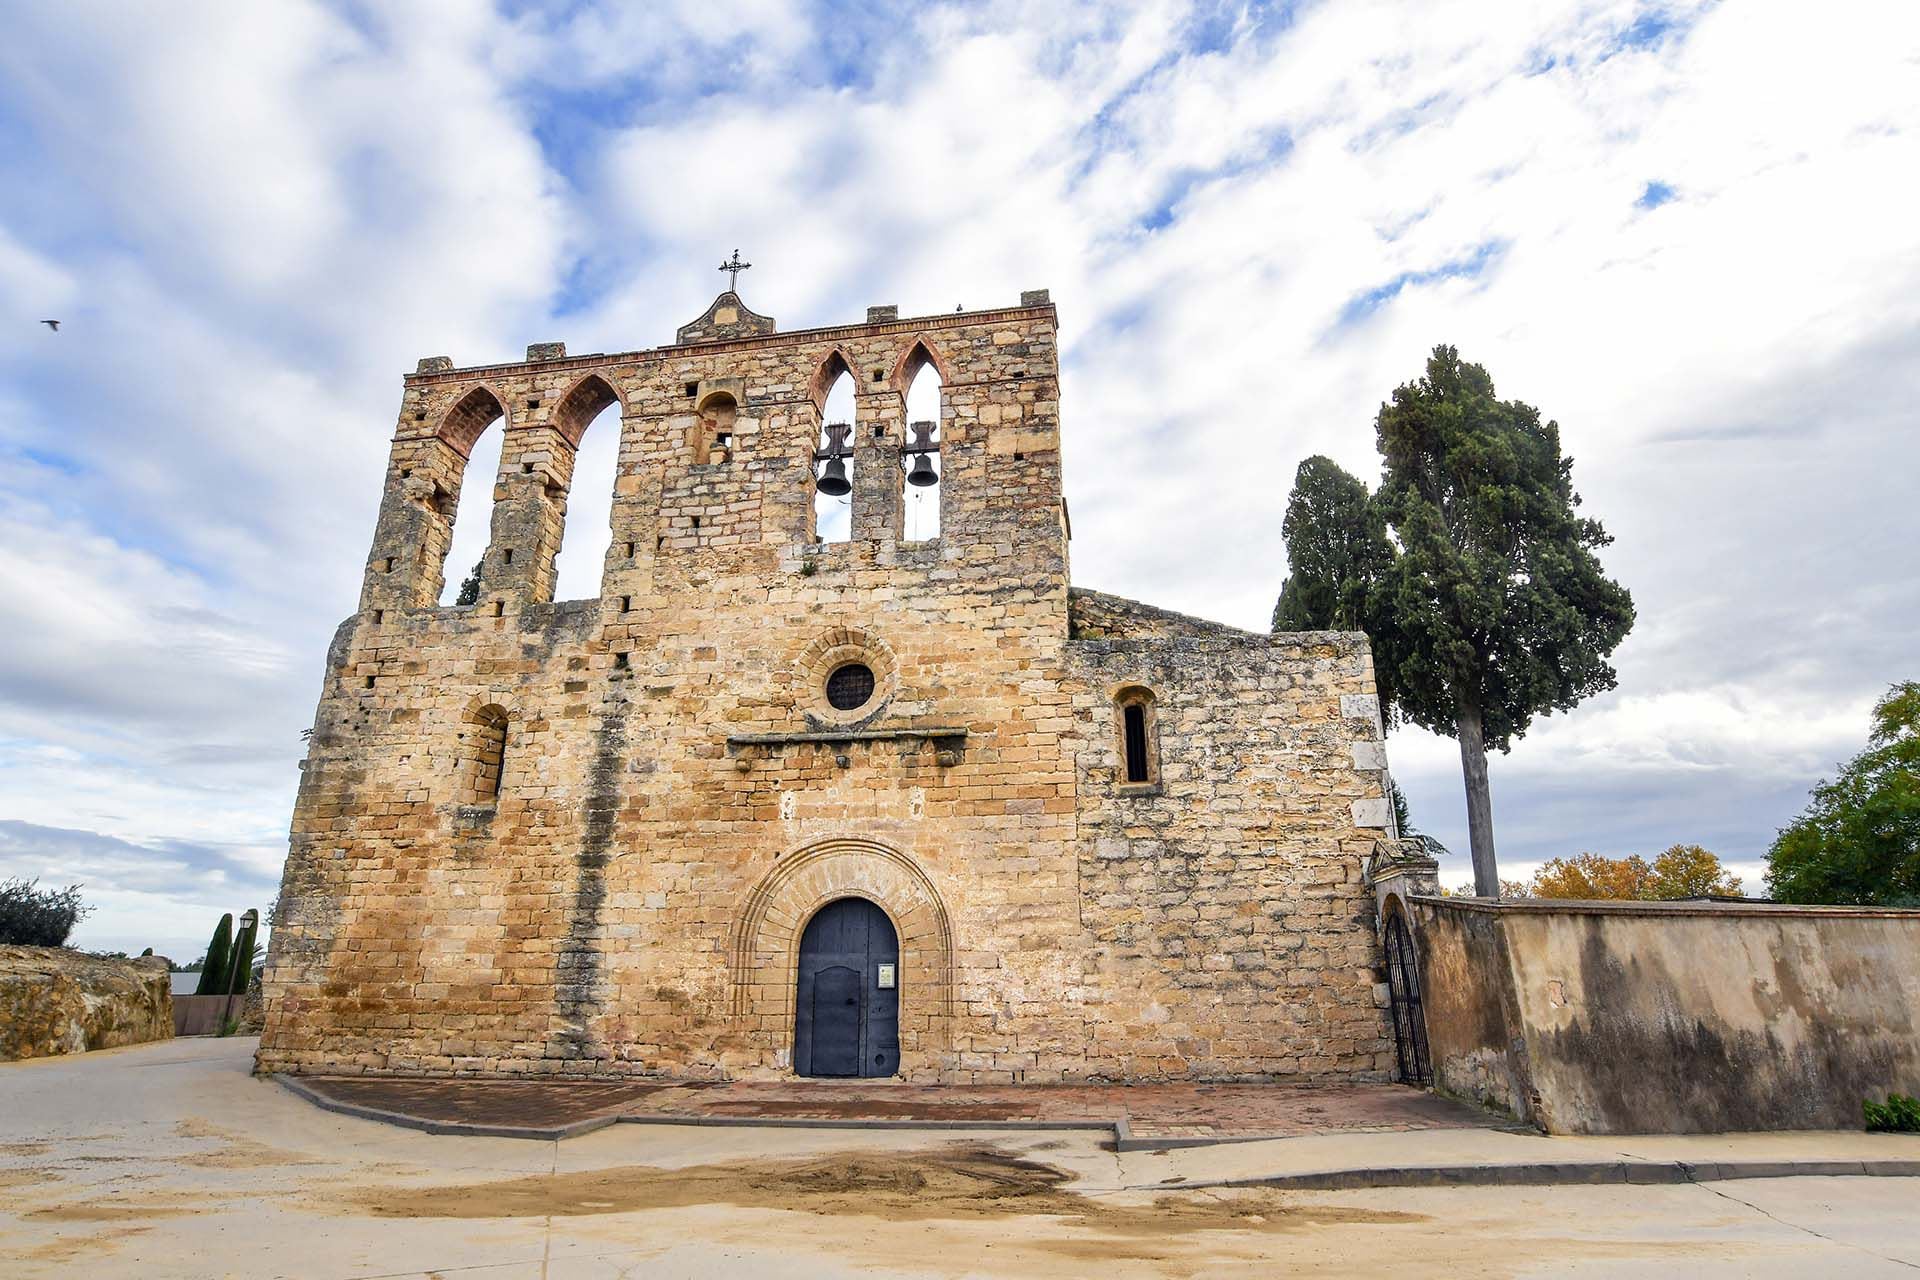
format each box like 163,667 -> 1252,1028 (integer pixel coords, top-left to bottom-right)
0,0 -> 1920,958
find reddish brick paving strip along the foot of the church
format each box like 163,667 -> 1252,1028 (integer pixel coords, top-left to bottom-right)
288,1077 -> 1494,1140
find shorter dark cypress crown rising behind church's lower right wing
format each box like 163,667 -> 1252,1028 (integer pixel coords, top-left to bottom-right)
1273,455 -> 1394,631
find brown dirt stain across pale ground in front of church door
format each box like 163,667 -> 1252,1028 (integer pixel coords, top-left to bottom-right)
349,1146 -> 1427,1236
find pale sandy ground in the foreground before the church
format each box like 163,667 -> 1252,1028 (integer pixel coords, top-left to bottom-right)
0,1040 -> 1920,1280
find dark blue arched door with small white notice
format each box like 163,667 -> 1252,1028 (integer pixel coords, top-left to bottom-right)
793,898 -> 900,1077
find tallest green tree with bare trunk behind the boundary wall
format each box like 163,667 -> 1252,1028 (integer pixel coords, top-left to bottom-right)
1375,345 -> 1634,896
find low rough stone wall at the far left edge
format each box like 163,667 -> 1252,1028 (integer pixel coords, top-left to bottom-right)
0,946 -> 173,1061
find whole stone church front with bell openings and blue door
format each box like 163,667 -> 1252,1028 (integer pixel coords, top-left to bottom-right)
259,292 -> 1394,1082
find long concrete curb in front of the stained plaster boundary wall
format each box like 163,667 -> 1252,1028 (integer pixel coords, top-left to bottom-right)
1152,1159 -> 1920,1192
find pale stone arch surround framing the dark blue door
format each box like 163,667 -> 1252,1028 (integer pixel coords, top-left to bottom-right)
732,837 -> 954,1079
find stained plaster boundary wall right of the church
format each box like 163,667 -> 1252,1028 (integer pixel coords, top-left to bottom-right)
1407,896 -> 1920,1134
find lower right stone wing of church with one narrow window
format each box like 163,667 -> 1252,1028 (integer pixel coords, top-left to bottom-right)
1069,591 -> 1394,1079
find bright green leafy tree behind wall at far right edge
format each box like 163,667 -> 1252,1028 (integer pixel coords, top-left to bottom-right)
1766,679 -> 1920,906
